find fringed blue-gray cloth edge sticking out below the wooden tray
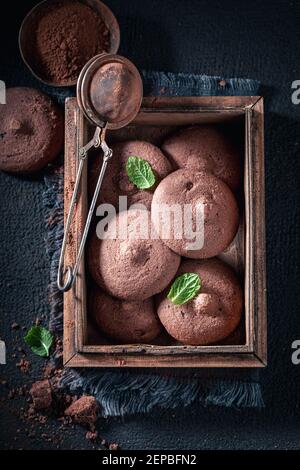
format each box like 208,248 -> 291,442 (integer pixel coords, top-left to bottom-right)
61,369 -> 264,416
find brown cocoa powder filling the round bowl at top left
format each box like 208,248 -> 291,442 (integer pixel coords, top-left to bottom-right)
31,0 -> 110,85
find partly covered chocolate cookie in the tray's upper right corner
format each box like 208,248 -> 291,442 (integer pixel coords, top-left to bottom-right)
161,125 -> 241,190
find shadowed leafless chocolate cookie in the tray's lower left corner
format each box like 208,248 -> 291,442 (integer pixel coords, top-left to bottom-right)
90,287 -> 162,343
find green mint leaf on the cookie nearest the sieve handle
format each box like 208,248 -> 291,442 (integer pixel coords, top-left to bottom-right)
126,155 -> 155,189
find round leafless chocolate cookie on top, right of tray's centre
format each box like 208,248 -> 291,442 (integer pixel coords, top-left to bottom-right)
151,170 -> 239,259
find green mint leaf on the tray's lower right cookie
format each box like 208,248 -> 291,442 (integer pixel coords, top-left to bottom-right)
168,273 -> 201,305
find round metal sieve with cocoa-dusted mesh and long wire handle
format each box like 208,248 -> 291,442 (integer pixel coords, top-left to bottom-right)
57,54 -> 143,292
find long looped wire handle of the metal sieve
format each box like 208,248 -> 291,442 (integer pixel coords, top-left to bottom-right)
57,127 -> 112,292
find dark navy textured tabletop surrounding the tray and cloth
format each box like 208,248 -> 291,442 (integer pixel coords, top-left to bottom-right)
0,0 -> 300,449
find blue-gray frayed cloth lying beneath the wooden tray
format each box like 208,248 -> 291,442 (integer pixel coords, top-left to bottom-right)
43,72 -> 264,416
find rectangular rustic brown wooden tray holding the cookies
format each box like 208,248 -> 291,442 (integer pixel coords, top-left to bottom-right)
64,96 -> 267,367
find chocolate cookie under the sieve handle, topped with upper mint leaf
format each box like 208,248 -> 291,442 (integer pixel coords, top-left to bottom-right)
90,140 -> 172,209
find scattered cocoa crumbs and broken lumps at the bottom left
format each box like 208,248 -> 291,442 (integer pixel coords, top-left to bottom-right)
0,320 -> 120,450
